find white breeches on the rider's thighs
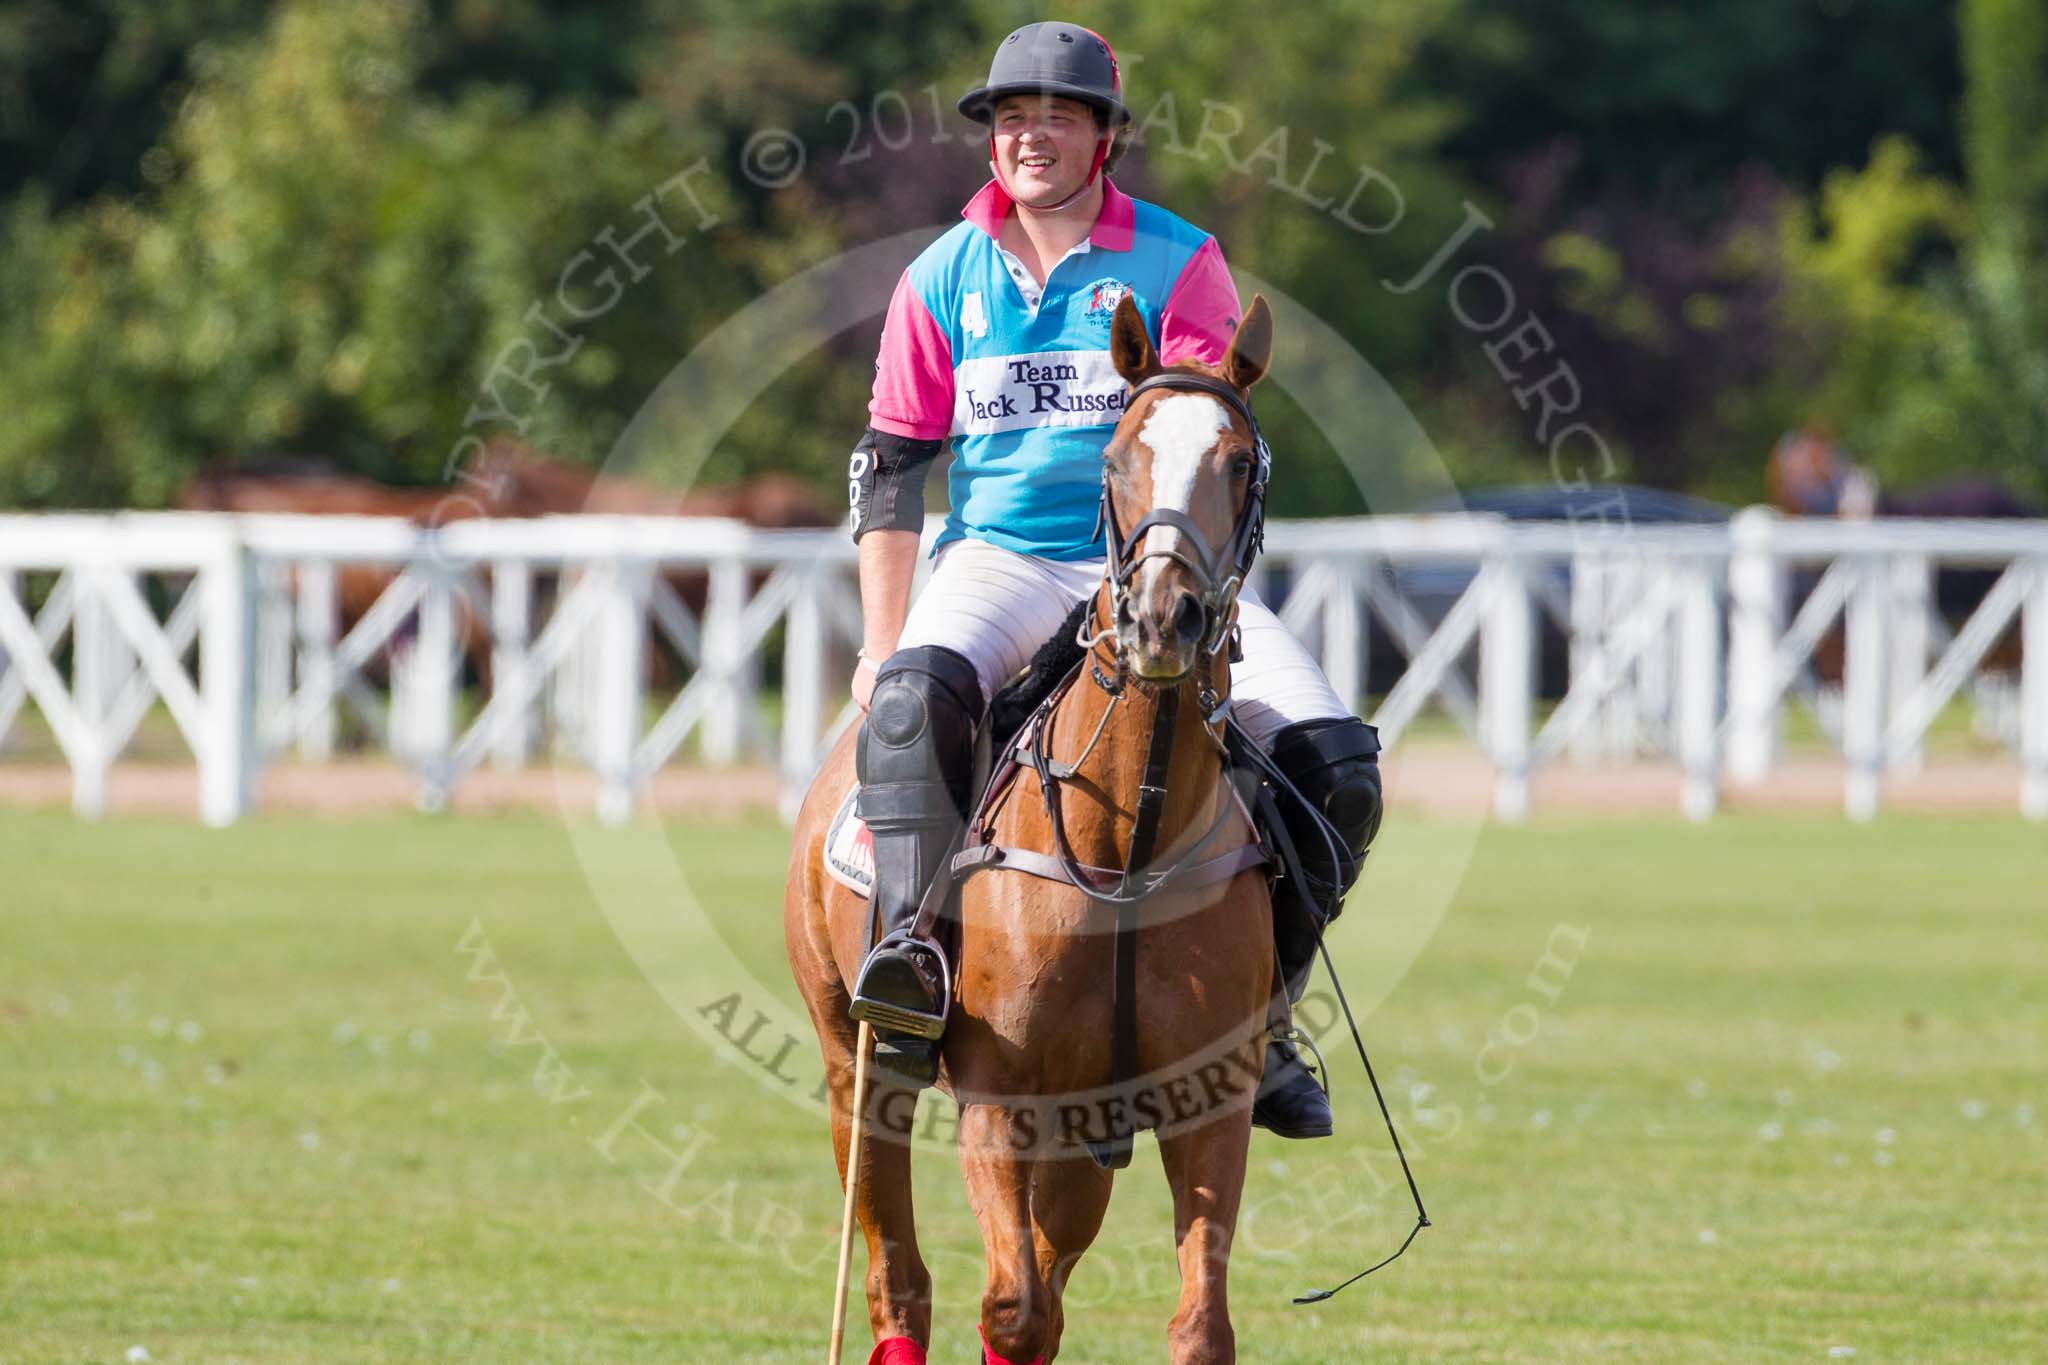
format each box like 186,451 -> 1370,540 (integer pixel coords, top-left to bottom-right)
897,540 -> 1352,745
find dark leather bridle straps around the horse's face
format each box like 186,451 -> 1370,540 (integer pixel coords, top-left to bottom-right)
1083,370 -> 1272,655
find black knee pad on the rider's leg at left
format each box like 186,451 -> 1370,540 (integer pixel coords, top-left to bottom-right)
854,645 -> 981,831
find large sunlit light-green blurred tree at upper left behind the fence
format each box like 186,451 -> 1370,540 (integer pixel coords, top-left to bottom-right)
0,0 -> 748,503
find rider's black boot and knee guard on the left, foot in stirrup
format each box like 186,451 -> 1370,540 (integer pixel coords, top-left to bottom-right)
852,647 -> 981,1085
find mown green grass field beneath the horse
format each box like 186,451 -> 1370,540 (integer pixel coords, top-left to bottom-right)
0,812 -> 2048,1365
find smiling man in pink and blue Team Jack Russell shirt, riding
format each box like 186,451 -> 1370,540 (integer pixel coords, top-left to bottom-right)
850,23 -> 1380,1138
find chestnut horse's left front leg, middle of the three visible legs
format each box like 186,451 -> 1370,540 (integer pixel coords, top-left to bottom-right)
961,1103 -> 1053,1365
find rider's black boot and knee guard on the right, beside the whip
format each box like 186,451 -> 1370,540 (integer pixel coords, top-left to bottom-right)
1251,718 -> 1380,1138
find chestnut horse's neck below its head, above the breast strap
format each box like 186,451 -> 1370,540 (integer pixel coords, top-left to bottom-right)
1051,598 -> 1231,868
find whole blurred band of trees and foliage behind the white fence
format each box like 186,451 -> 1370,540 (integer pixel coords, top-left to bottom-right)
0,0 -> 2048,514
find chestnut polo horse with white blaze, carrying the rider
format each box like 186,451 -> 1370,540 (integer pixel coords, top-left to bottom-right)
784,297 -> 1272,1365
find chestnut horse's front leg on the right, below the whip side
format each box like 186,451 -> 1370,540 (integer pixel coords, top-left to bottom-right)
1159,1111 -> 1251,1365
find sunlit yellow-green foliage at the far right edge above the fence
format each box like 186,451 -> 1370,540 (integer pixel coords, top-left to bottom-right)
1784,0 -> 2048,497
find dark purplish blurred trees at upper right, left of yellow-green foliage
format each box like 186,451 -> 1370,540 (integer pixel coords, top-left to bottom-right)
1411,0 -> 1960,499
